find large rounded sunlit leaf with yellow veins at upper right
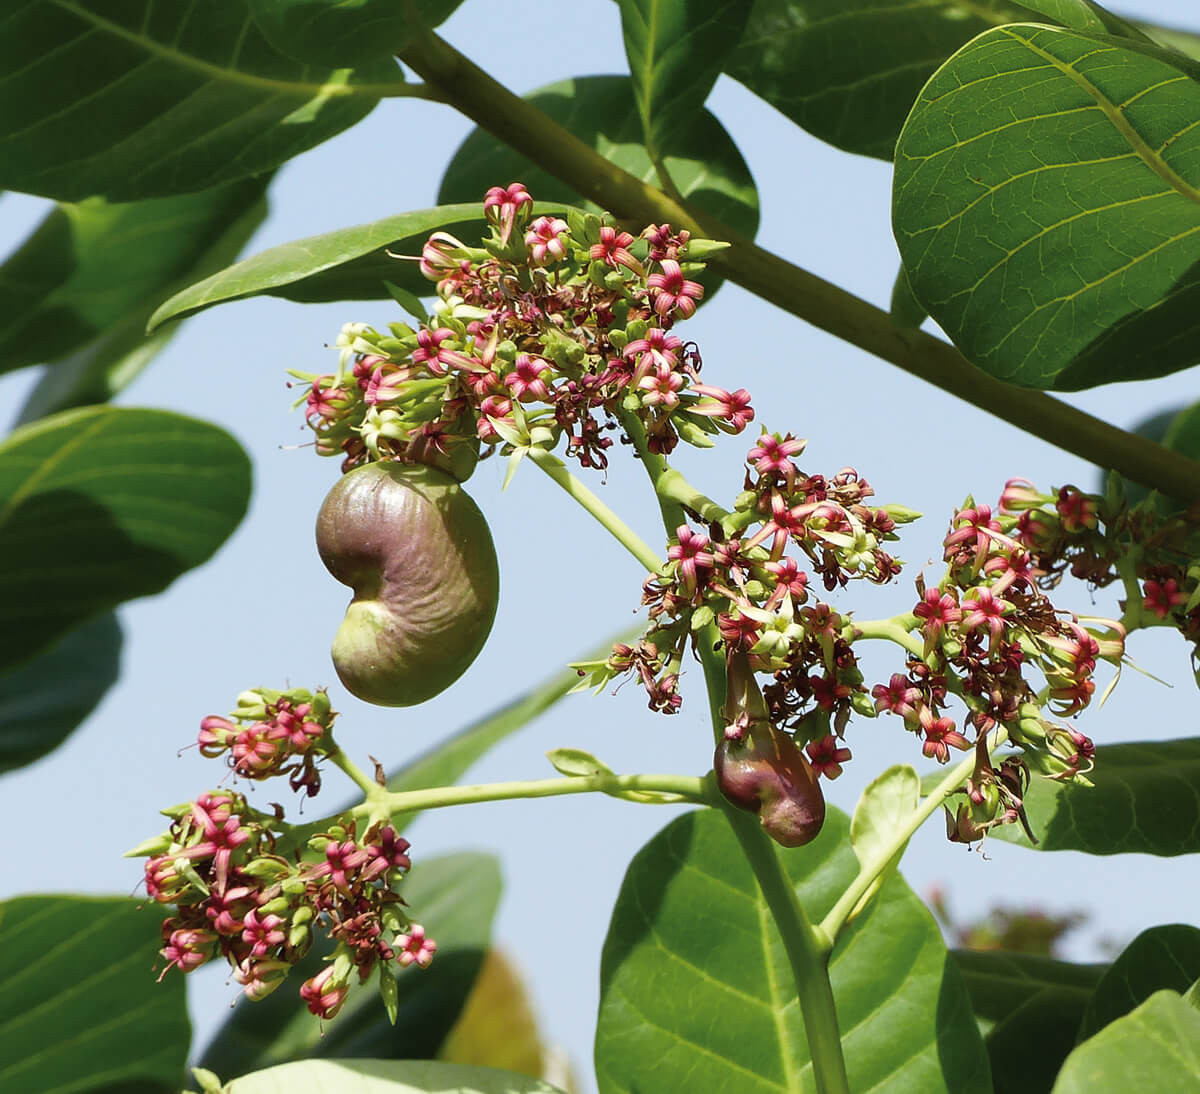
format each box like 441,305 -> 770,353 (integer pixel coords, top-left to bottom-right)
893,25 -> 1200,390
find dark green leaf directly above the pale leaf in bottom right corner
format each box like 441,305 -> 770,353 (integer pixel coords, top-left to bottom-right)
1079,924 -> 1200,1041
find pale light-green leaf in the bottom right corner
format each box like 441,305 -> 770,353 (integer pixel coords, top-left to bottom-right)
1054,991 -> 1200,1094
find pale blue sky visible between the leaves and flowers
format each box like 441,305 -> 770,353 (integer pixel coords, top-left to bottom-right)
0,0 -> 1200,1090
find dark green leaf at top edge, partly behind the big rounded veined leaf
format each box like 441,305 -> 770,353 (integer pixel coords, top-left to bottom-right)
725,0 -> 1141,160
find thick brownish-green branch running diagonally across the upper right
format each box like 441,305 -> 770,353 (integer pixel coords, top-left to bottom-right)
400,30 -> 1200,499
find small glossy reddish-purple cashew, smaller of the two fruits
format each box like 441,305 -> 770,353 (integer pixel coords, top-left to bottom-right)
713,722 -> 824,847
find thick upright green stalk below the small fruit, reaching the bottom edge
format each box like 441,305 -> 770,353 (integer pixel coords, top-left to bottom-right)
725,806 -> 850,1094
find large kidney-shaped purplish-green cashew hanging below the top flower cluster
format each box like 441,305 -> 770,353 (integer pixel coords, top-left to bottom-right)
317,462 -> 500,707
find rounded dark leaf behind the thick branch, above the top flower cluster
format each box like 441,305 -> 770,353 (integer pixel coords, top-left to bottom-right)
438,76 -> 758,245
